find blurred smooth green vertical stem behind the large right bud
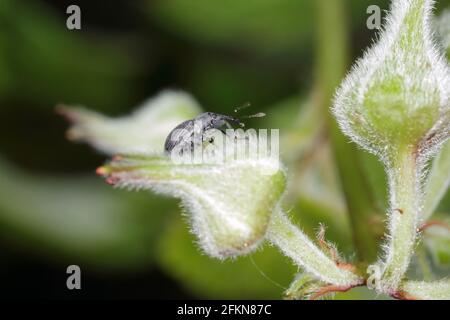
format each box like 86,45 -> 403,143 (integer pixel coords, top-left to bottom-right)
315,0 -> 378,262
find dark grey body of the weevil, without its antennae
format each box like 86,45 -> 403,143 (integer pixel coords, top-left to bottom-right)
164,112 -> 243,153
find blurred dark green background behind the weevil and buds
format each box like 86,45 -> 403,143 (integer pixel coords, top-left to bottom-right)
0,0 -> 450,299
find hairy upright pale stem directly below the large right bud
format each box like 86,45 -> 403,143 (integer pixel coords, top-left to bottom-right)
381,151 -> 421,293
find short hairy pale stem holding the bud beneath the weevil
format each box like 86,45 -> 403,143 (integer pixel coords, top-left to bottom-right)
267,209 -> 363,286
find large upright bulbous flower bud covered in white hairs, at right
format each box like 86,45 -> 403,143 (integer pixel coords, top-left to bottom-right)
333,0 -> 450,162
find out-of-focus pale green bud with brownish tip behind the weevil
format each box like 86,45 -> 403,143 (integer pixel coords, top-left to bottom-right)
57,91 -> 200,155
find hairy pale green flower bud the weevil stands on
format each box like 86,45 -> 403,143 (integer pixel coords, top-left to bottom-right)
98,145 -> 285,259
